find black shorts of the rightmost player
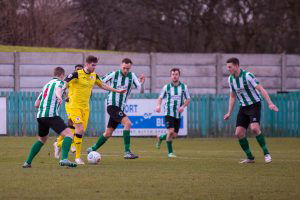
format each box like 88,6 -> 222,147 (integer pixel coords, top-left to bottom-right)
236,102 -> 261,129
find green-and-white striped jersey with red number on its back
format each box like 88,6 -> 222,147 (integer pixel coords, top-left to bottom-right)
37,78 -> 65,118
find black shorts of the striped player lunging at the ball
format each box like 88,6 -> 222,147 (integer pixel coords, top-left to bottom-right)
107,106 -> 126,129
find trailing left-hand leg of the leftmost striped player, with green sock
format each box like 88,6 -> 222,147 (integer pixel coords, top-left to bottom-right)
23,118 -> 49,168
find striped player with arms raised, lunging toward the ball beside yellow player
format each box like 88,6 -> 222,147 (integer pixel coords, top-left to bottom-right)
87,58 -> 145,159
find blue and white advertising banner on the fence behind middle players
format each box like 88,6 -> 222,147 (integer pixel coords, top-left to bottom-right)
105,99 -> 187,136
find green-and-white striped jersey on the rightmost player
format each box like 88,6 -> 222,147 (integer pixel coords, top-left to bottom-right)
228,69 -> 262,106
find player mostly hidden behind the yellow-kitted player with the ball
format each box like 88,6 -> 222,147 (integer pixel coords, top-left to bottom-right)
53,64 -> 83,159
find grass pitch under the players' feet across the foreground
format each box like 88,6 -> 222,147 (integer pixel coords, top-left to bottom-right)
0,137 -> 300,200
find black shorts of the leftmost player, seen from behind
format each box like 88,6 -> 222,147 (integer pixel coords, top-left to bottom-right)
37,116 -> 67,137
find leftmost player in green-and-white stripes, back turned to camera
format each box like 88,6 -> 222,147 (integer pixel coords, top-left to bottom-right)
23,67 -> 77,168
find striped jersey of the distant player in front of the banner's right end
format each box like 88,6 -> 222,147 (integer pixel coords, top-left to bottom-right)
159,82 -> 191,119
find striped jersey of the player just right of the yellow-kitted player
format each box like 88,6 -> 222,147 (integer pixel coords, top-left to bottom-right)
101,70 -> 141,110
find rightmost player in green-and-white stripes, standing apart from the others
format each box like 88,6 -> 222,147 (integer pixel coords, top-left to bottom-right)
224,58 -> 278,163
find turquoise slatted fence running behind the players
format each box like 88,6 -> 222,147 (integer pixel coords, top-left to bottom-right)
0,92 -> 300,137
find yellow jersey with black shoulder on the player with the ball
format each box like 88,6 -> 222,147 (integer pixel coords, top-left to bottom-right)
65,69 -> 102,108
